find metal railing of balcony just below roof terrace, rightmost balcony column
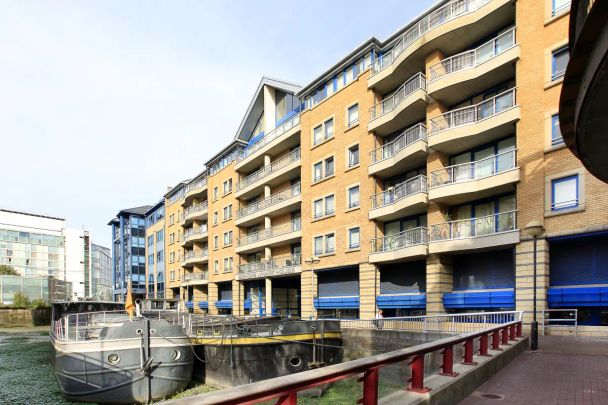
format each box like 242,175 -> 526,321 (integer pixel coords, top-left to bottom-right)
429,27 -> 516,82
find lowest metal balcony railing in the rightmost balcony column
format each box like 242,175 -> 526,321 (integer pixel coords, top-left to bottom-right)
430,210 -> 517,241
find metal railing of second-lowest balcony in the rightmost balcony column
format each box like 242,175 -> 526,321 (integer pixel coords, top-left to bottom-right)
430,149 -> 517,188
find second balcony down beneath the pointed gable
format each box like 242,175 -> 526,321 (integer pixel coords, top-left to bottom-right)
235,148 -> 302,199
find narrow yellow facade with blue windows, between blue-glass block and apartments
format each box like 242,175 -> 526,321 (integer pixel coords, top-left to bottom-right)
146,199 -> 165,298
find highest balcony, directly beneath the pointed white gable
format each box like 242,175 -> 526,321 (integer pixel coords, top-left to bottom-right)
234,113 -> 300,172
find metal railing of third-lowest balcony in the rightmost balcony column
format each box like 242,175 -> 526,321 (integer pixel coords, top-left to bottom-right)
431,88 -> 516,135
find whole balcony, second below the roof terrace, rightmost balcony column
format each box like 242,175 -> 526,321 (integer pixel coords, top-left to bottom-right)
428,88 -> 521,155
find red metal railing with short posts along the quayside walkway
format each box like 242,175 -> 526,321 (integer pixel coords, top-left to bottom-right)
165,318 -> 522,405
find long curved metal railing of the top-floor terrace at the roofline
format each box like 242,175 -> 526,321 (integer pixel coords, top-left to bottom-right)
370,0 -> 492,77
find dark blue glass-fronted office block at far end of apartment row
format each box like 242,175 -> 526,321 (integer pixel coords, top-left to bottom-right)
108,205 -> 152,302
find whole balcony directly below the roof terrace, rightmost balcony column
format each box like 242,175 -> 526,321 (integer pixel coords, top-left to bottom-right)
428,28 -> 520,105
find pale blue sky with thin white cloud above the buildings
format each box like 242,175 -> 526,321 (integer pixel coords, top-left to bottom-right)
0,0 -> 435,247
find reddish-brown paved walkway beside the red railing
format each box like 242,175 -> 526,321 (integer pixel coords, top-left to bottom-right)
460,336 -> 608,405
